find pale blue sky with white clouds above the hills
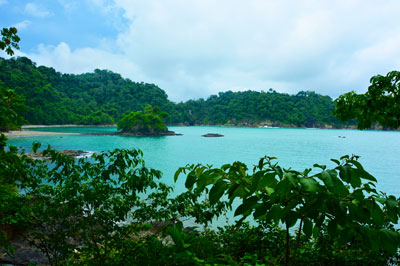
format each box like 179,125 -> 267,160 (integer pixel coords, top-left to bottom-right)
0,0 -> 400,101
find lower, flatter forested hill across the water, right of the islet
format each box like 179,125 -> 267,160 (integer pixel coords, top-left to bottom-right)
177,89 -> 346,127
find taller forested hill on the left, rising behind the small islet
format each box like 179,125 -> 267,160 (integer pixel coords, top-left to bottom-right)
0,57 -> 178,124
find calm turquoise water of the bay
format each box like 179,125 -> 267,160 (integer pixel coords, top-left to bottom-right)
9,127 -> 400,196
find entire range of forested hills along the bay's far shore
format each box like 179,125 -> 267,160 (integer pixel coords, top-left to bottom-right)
0,57 -> 350,127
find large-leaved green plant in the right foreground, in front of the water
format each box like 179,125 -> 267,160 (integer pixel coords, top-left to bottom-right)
175,156 -> 400,265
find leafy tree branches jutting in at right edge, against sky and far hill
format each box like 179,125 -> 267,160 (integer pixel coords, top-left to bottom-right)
334,71 -> 400,129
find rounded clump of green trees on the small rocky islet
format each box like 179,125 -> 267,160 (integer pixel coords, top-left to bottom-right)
117,105 -> 168,134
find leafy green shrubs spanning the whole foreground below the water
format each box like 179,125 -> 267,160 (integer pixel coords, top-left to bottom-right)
0,138 -> 400,265
